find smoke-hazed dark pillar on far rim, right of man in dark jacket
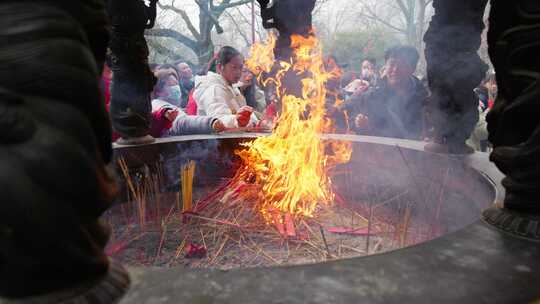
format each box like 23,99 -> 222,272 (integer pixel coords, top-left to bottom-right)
424,0 -> 487,153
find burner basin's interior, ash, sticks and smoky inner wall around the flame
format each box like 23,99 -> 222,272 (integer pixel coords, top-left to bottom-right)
105,146 -> 484,269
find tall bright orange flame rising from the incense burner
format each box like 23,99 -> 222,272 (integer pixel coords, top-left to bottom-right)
236,35 -> 352,223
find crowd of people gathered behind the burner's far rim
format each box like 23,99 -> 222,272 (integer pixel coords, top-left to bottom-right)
103,46 -> 496,150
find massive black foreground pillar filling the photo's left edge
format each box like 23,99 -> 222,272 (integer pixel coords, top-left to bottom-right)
0,0 -> 129,303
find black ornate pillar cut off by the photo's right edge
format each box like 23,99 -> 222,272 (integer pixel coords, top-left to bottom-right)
484,0 -> 540,240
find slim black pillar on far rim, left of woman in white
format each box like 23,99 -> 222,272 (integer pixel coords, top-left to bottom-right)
107,0 -> 157,144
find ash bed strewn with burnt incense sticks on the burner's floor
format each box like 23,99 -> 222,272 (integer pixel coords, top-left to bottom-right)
105,160 -> 448,269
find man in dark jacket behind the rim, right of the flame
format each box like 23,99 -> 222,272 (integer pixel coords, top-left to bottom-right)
340,46 -> 428,140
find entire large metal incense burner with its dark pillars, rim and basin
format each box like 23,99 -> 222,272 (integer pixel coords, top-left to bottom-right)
0,0 -> 540,304
